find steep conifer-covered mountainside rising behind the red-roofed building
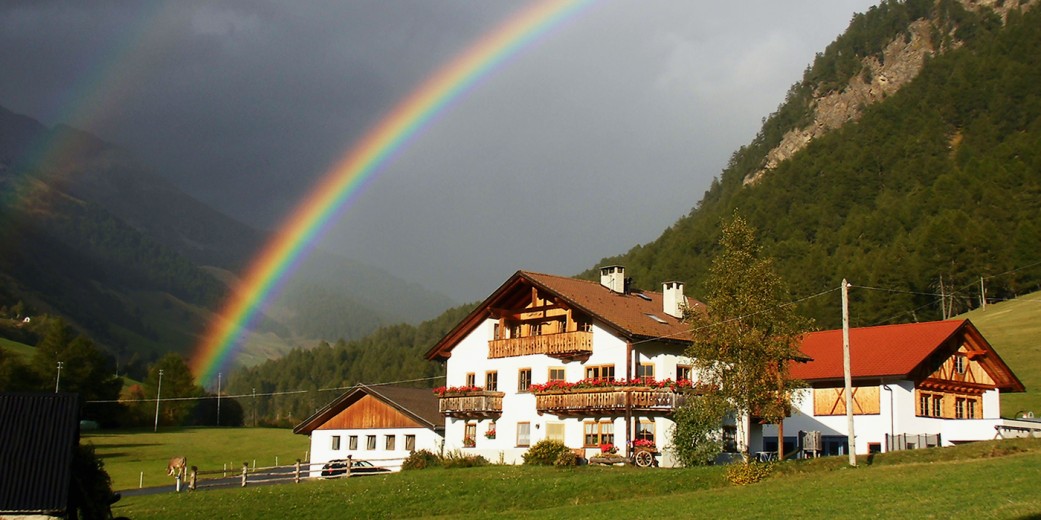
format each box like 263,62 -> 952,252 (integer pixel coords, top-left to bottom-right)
583,0 -> 1041,327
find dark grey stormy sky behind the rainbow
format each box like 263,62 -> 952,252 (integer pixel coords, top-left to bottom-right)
0,0 -> 877,302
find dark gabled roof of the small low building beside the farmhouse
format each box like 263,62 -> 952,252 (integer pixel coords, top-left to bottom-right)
293,384 -> 445,435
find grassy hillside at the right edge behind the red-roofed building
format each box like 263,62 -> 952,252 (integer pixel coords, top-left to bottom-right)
959,292 -> 1041,417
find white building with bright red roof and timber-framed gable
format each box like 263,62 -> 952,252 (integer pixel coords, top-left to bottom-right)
752,319 -> 1024,454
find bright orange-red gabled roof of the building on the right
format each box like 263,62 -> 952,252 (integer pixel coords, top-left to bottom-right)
791,319 -> 1023,392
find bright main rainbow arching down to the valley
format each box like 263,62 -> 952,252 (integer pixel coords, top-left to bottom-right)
191,0 -> 592,386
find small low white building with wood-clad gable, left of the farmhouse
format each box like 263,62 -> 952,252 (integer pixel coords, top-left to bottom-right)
293,385 -> 445,476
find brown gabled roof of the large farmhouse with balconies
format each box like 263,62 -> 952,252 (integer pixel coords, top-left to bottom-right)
426,270 -> 702,360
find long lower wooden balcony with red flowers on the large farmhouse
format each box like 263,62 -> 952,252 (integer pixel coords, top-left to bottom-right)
535,387 -> 686,415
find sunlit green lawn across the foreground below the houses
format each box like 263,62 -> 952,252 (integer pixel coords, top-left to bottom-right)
113,439 -> 1041,519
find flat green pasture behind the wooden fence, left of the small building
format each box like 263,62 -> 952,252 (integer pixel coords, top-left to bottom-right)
81,427 -> 309,490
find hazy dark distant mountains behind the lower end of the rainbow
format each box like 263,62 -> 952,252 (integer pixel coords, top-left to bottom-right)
0,107 -> 452,370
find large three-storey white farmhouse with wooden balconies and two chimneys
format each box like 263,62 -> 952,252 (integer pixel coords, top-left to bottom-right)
427,266 -> 701,466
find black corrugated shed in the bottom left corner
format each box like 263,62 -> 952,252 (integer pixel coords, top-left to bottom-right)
0,393 -> 79,518
